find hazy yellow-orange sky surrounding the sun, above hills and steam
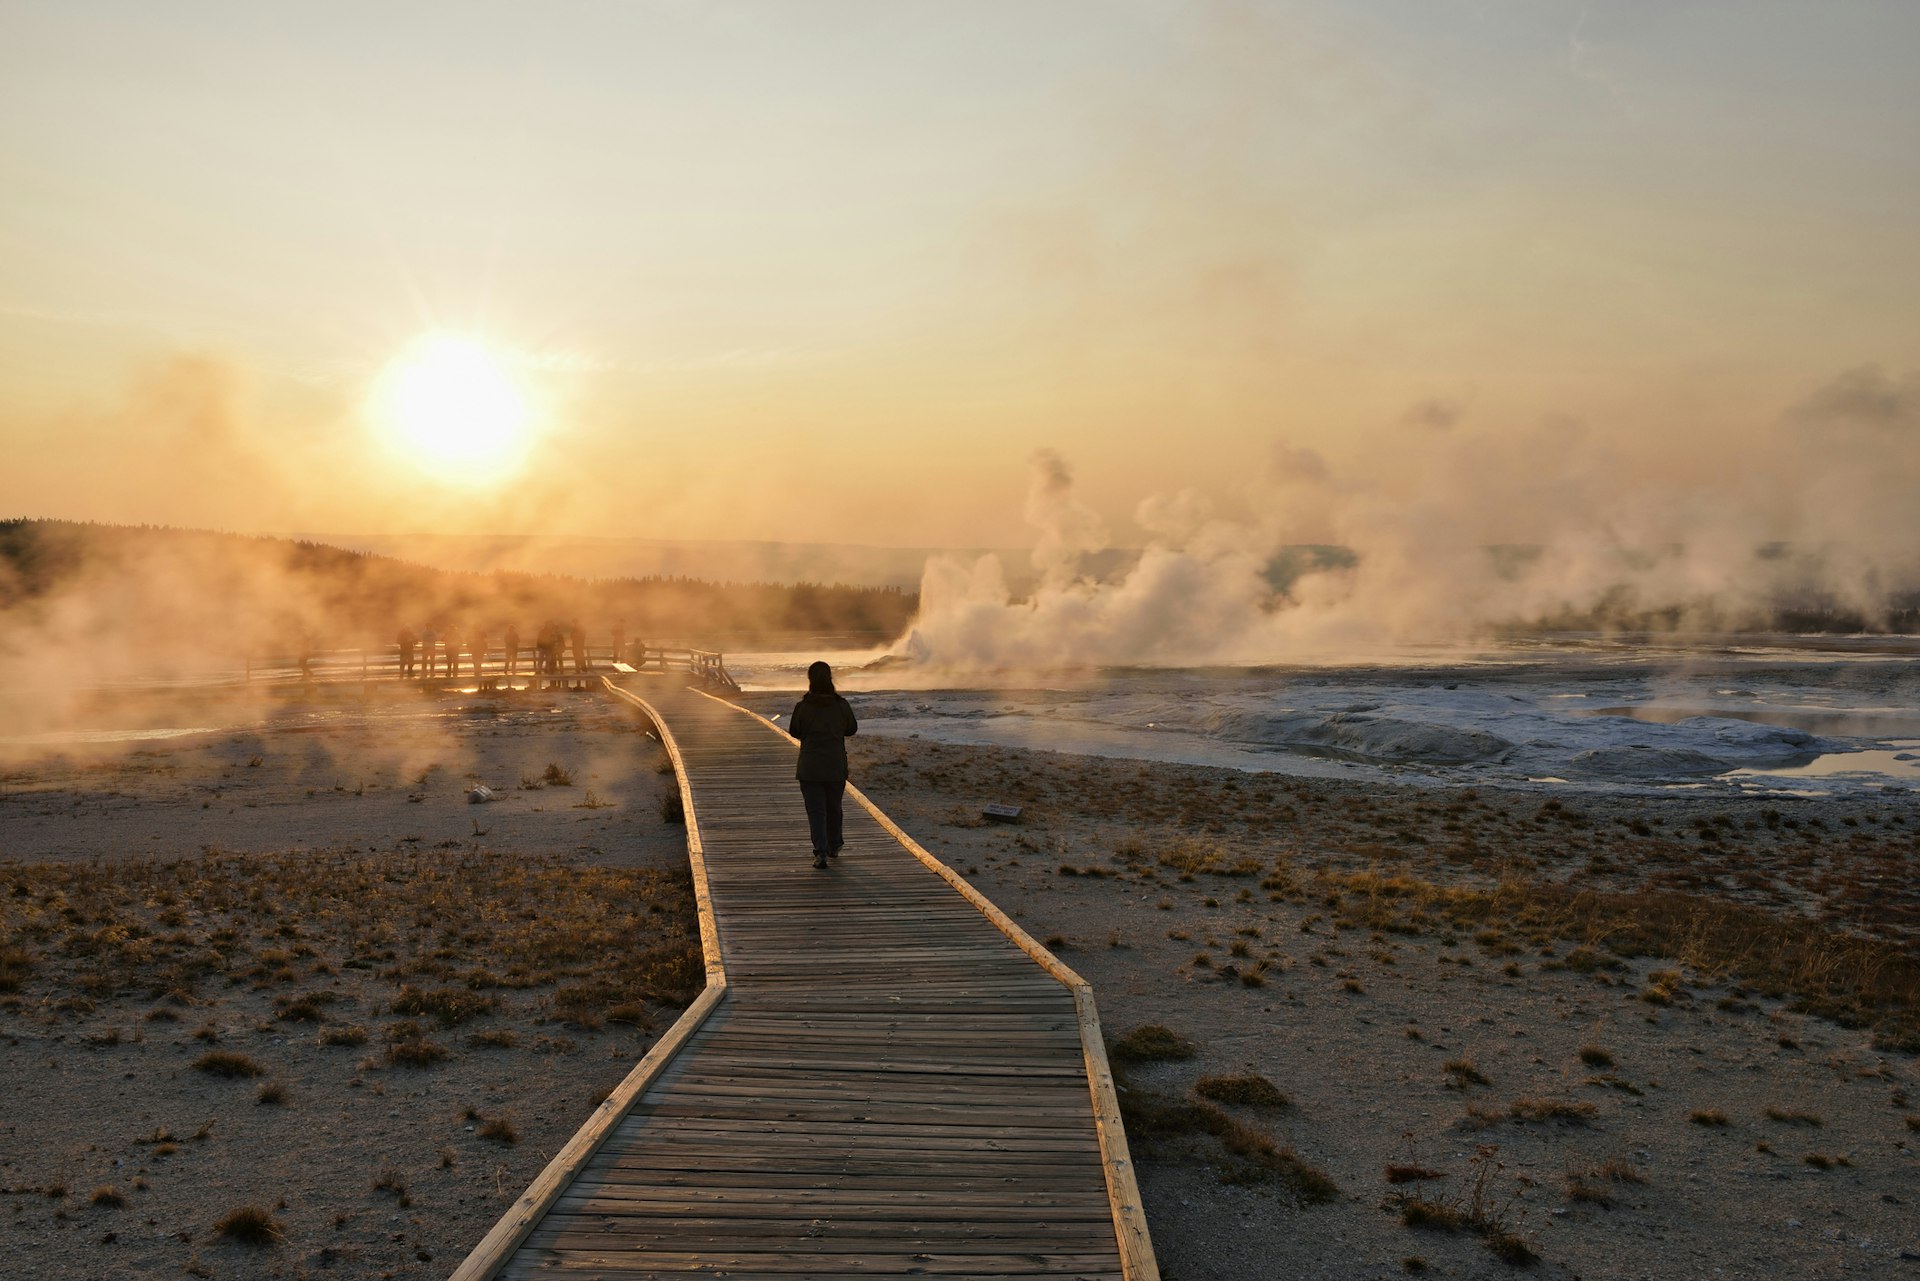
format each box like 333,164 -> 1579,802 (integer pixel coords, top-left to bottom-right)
0,0 -> 1920,545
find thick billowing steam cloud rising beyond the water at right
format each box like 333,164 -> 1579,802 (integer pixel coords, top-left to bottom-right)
895,367 -> 1920,670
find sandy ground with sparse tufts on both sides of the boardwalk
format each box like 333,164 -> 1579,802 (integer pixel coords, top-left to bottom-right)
0,695 -> 1920,1281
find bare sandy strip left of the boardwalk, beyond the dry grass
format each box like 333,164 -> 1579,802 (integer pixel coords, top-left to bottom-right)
0,691 -> 685,866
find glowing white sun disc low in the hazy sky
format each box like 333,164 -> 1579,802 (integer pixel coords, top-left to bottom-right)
371,330 -> 538,486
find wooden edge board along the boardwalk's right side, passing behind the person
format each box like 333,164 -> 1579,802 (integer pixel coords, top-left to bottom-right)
699,689 -> 1160,1281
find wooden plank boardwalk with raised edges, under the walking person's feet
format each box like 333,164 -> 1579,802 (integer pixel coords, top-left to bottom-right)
453,678 -> 1158,1281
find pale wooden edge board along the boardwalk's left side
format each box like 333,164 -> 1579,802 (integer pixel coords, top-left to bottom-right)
447,678 -> 726,1281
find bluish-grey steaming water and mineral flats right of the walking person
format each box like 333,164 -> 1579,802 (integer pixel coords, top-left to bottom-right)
728,638 -> 1920,795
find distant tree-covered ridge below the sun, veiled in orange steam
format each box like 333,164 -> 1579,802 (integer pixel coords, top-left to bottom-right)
0,520 -> 918,651
